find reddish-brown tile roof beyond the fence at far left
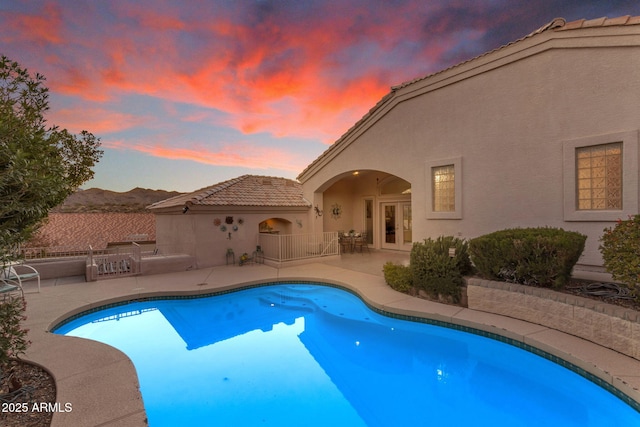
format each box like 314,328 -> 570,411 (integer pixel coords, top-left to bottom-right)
25,213 -> 156,249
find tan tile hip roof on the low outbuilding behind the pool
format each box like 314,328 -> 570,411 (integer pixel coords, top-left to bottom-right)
148,175 -> 311,210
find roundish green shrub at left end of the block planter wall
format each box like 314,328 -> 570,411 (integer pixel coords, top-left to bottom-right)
410,236 -> 471,303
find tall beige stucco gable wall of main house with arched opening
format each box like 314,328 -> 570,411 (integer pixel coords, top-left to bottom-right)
301,28 -> 640,265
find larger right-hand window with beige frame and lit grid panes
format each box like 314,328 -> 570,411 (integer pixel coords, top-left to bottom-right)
563,130 -> 638,221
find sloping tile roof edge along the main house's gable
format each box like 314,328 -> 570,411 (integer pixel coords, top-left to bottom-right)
298,15 -> 640,179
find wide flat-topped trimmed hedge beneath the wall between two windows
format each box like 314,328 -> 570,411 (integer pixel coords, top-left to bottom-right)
469,227 -> 587,288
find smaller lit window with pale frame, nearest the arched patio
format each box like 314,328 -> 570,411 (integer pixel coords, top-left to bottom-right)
425,157 -> 462,219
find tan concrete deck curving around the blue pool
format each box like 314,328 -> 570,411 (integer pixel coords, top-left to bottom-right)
18,251 -> 640,426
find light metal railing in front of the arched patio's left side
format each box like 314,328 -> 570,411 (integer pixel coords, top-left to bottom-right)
258,231 -> 340,262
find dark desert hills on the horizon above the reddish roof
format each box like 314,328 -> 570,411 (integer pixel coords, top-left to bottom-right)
52,188 -> 181,213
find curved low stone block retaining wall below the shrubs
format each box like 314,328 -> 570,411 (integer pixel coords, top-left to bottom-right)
467,278 -> 640,360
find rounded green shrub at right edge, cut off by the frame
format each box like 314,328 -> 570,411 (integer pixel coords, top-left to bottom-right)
600,215 -> 640,295
